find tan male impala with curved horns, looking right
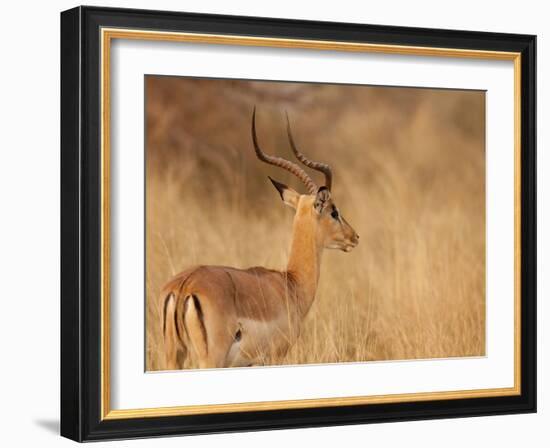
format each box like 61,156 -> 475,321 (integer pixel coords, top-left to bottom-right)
160,110 -> 359,369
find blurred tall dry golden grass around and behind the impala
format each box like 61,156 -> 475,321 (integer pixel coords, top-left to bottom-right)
146,77 -> 485,370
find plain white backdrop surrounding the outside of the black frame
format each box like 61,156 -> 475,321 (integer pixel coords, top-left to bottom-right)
0,0 -> 550,447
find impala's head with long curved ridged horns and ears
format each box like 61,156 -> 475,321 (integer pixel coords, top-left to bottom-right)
252,109 -> 359,252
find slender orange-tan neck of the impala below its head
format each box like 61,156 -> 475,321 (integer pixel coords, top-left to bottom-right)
287,198 -> 323,315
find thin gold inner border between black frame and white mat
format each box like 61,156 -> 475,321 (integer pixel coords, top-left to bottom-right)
100,28 -> 521,420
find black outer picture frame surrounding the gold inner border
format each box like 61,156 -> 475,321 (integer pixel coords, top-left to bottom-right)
61,7 -> 536,441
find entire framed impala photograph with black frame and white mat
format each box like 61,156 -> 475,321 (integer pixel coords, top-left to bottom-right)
61,7 -> 536,441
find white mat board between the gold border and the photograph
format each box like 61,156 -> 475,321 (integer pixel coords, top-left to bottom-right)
111,40 -> 514,409
